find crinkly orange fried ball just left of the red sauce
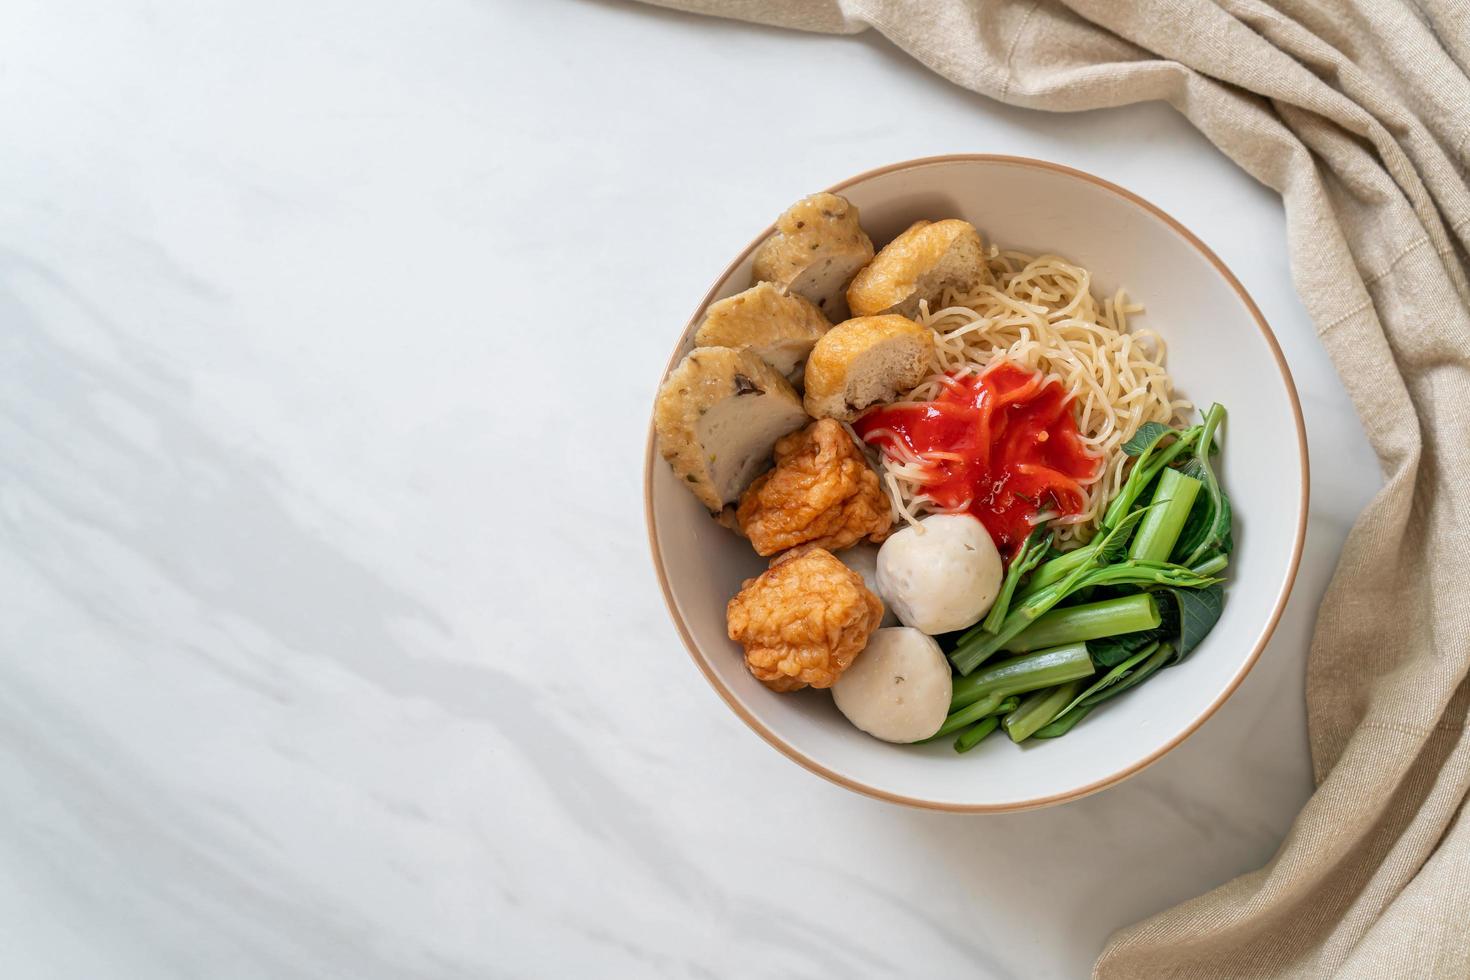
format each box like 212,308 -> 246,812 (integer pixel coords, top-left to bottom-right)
735,419 -> 894,555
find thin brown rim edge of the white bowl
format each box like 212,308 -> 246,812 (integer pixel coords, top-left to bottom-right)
644,153 -> 1311,813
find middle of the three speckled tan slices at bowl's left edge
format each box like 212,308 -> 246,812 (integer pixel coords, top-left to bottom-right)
694,282 -> 831,385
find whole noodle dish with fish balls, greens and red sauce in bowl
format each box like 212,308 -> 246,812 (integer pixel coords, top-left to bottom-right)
654,194 -> 1233,752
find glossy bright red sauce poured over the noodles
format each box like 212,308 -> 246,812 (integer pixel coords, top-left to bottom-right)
853,360 -> 1103,561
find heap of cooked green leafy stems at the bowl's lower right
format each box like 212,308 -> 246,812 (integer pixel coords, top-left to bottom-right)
939,406 -> 1233,752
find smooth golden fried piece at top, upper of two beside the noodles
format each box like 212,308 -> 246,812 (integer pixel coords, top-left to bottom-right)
847,217 -> 985,317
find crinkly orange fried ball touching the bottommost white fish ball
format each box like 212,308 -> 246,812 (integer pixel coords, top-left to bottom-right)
725,548 -> 883,691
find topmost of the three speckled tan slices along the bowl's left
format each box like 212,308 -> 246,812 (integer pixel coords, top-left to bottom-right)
751,194 -> 873,323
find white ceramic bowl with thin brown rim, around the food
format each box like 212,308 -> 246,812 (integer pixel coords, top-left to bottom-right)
645,156 -> 1307,811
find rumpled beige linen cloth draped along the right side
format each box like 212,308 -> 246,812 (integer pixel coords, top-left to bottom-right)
637,0 -> 1470,980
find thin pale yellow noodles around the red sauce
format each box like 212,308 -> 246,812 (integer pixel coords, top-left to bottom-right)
869,245 -> 1192,548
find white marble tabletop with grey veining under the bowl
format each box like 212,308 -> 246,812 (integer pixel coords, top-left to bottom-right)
0,0 -> 1377,980
